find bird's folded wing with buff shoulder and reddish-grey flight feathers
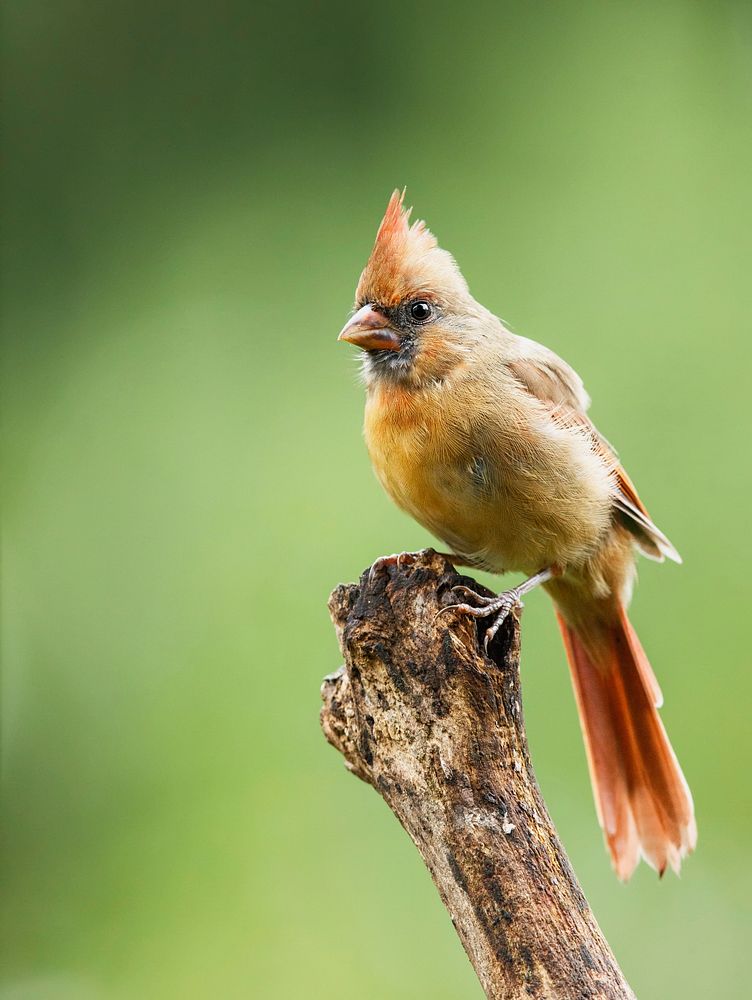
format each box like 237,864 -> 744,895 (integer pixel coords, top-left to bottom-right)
507,350 -> 681,562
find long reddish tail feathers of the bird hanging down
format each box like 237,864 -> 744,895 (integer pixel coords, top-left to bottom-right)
557,608 -> 697,880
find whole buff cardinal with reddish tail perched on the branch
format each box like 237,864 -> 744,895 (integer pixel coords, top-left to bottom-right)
339,191 -> 697,879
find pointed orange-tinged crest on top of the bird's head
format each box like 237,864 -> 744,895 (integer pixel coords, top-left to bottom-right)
357,189 -> 467,305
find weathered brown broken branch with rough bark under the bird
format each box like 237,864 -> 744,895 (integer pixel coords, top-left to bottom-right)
321,549 -> 633,1000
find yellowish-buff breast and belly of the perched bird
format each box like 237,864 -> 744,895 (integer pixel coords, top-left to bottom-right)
365,380 -> 609,572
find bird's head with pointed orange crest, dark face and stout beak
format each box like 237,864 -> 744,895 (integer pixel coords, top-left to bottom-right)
339,191 -> 485,387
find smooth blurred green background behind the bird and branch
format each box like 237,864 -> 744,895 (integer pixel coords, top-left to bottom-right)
0,0 -> 752,1000
